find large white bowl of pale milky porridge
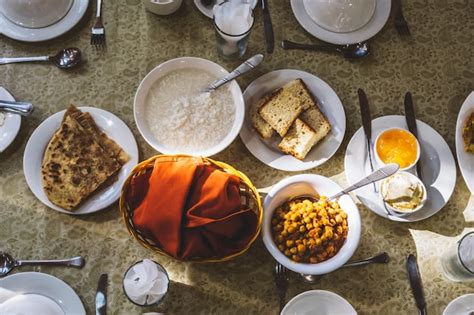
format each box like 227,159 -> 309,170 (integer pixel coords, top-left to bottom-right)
133,57 -> 245,156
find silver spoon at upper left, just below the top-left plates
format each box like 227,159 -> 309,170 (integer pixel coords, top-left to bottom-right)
0,47 -> 82,69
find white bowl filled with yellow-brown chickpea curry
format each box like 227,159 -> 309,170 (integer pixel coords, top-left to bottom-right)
262,174 -> 361,275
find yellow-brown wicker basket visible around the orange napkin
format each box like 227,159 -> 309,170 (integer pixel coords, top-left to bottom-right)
120,155 -> 263,262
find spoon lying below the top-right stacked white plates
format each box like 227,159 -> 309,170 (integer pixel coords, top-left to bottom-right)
281,40 -> 369,59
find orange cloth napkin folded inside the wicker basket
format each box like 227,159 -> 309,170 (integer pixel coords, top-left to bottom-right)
127,156 -> 258,260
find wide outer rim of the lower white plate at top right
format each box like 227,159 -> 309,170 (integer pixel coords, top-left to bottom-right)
291,0 -> 391,45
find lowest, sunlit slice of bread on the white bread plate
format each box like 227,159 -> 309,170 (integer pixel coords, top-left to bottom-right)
278,118 -> 318,160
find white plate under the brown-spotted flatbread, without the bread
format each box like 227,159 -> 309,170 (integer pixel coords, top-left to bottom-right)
23,107 -> 138,214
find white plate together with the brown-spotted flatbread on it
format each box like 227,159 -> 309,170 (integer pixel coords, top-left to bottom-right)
23,105 -> 138,214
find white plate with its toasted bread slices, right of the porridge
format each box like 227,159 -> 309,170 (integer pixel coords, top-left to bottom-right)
240,69 -> 346,171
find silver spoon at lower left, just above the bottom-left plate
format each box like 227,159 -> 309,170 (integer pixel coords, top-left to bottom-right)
0,253 -> 85,277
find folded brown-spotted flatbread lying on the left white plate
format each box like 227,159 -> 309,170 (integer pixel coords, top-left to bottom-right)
41,115 -> 122,210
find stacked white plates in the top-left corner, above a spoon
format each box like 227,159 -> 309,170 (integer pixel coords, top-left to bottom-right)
0,0 -> 89,42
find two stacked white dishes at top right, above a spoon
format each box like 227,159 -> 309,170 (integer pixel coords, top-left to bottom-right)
291,0 -> 391,45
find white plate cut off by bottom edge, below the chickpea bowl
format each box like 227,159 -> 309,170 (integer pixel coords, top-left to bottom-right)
281,290 -> 357,315
